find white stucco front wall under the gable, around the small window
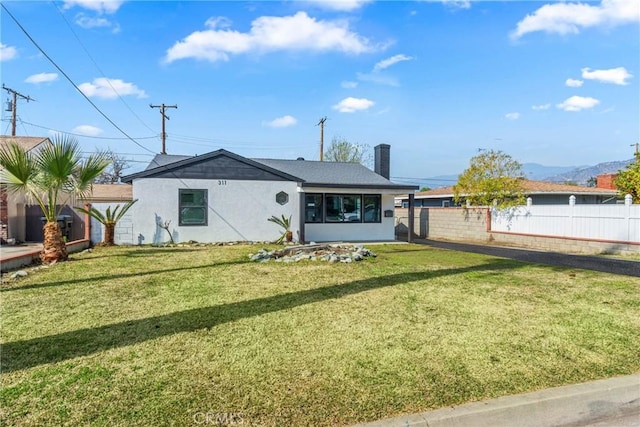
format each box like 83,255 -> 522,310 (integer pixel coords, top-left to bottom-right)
131,178 -> 299,244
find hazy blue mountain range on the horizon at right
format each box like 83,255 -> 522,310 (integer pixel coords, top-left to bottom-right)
418,159 -> 635,188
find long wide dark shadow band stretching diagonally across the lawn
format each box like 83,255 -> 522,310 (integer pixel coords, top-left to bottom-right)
0,260 -> 524,372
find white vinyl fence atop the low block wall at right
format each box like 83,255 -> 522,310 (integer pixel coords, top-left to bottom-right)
491,196 -> 640,243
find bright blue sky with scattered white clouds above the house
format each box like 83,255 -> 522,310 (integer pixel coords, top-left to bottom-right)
0,0 -> 640,183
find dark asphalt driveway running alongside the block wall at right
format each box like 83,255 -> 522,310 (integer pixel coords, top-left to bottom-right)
413,239 -> 640,277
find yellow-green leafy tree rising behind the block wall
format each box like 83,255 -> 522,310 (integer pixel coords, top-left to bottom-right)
453,150 -> 525,208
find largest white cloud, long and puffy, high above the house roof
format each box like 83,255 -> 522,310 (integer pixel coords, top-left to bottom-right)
165,12 -> 382,63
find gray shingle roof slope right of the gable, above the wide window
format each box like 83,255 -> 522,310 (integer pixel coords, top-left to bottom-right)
251,159 -> 413,188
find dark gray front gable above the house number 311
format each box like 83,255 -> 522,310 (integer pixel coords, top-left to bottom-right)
122,150 -> 301,182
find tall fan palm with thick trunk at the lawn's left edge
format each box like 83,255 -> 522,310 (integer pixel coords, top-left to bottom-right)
0,136 -> 108,262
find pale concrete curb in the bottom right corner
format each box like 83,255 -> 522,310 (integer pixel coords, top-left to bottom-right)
359,374 -> 640,427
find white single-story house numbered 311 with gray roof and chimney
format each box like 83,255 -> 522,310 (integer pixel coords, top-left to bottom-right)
123,144 -> 418,243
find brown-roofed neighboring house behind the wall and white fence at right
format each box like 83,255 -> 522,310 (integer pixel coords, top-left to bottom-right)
396,180 -> 617,208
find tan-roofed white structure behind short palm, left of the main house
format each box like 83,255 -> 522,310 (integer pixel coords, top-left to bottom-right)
80,184 -> 137,245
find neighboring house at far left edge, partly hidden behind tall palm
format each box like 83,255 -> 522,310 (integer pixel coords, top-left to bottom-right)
0,135 -> 51,242
